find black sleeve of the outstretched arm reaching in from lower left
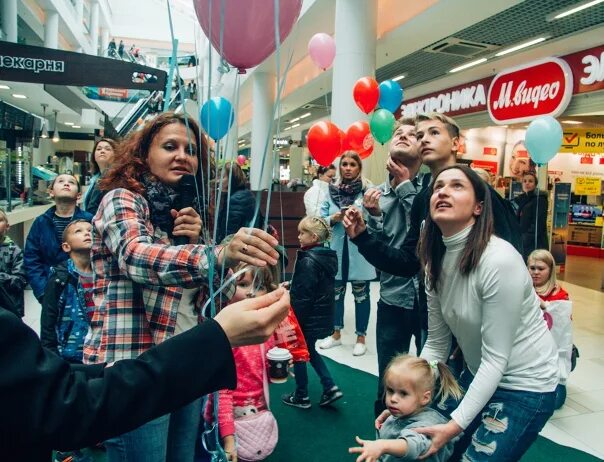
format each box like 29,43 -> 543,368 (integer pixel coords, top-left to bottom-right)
0,309 -> 236,462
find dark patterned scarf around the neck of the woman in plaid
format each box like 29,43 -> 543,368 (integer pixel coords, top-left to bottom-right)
140,174 -> 201,239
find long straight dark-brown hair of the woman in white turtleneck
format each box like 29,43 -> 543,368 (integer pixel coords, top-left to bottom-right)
417,165 -> 493,291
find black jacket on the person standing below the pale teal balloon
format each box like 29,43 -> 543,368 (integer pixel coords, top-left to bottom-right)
514,191 -> 548,260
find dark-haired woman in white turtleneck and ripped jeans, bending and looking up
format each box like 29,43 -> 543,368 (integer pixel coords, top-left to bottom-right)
419,166 -> 558,461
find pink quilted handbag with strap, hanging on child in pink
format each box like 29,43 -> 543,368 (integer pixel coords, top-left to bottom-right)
235,345 -> 279,462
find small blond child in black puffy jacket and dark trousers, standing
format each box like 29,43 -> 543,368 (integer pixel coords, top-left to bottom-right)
281,217 -> 344,409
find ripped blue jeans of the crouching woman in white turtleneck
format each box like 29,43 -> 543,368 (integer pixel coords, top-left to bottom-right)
441,369 -> 556,462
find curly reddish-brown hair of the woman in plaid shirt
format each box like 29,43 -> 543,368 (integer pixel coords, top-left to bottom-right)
99,112 -> 213,194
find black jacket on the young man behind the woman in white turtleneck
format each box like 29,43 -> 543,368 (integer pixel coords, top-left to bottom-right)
352,179 -> 522,278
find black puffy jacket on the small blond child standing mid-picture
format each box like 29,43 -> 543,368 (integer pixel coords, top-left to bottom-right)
290,247 -> 338,340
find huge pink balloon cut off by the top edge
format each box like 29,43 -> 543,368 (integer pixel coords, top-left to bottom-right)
194,0 -> 302,72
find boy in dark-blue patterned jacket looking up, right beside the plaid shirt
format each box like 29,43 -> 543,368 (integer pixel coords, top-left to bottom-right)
40,220 -> 94,364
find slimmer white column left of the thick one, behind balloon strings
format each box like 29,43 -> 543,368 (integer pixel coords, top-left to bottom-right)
250,72 -> 275,191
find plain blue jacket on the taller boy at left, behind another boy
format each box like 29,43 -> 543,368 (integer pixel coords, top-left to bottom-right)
23,206 -> 92,303
